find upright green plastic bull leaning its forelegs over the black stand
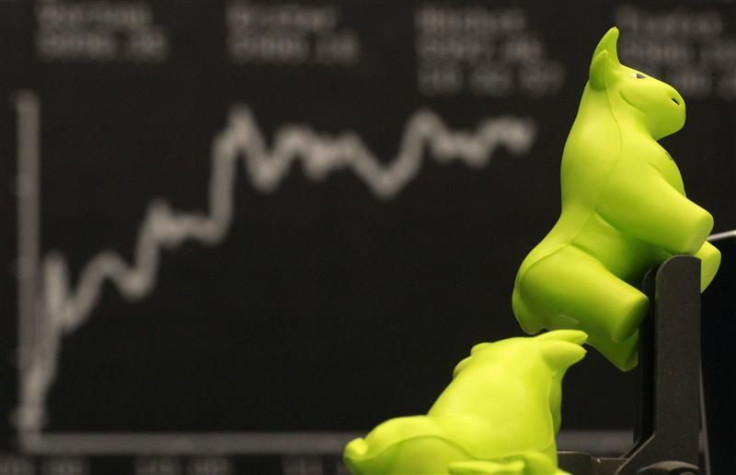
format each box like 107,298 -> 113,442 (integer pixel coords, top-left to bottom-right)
512,28 -> 720,370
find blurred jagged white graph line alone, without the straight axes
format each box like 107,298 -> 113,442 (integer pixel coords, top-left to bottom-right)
17,101 -> 536,433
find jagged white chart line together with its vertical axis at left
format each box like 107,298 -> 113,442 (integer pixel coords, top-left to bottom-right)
15,91 -> 536,448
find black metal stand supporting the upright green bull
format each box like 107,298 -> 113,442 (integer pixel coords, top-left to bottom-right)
559,256 -> 700,475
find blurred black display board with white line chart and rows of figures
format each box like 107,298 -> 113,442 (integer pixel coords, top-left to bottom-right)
0,0 -> 736,475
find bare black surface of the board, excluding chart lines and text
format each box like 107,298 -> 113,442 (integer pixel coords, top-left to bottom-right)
0,0 -> 736,473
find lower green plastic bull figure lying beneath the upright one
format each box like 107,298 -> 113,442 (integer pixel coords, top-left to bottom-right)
345,330 -> 587,475
